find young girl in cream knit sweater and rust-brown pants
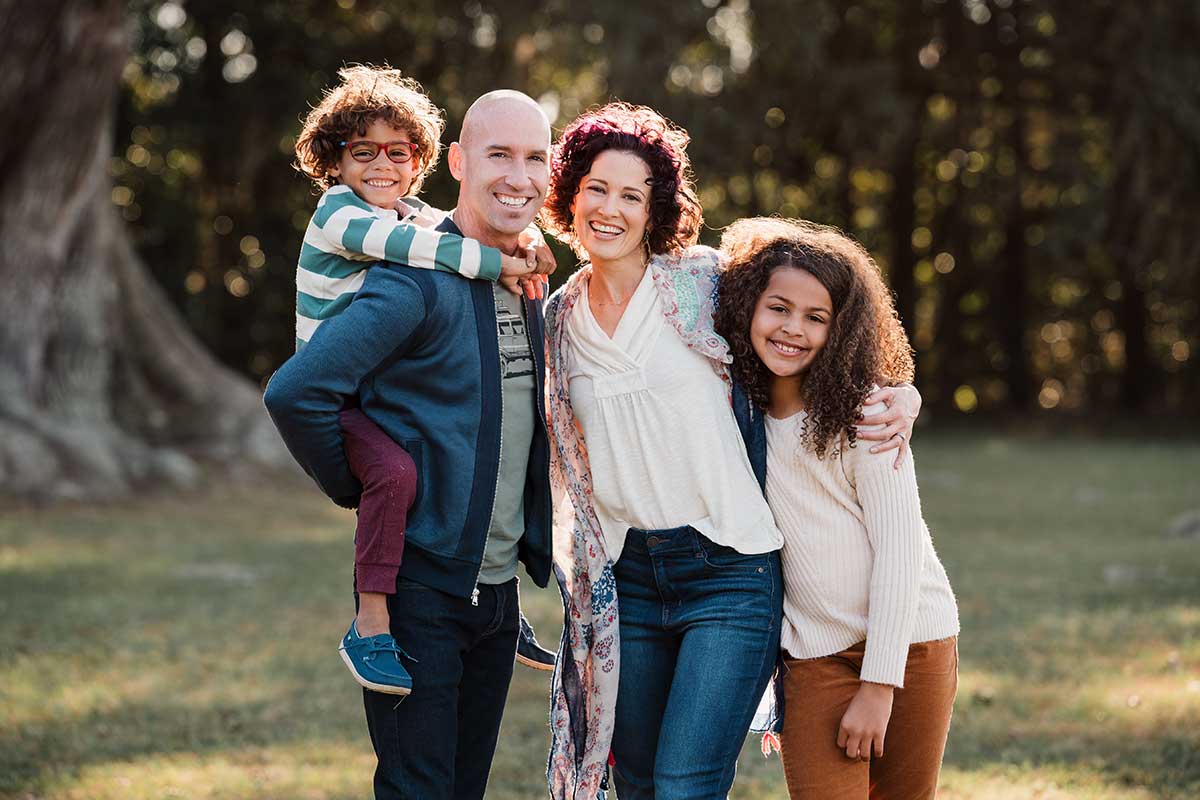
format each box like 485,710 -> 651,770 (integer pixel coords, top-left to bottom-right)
716,218 -> 959,800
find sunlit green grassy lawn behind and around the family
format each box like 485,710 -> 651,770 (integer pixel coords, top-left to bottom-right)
0,434 -> 1200,800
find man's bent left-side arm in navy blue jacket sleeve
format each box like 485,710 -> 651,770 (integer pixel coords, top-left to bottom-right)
263,266 -> 428,507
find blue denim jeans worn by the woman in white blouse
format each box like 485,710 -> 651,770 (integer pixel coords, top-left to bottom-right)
612,527 -> 784,800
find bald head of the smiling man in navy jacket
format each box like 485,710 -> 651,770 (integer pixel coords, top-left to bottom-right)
446,89 -> 550,252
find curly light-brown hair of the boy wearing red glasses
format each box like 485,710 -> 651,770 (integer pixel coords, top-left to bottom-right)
295,64 -> 445,194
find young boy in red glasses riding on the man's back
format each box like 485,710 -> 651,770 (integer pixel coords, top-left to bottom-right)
295,66 -> 553,694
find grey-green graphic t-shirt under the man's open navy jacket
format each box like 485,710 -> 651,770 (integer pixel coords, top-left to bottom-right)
479,285 -> 536,584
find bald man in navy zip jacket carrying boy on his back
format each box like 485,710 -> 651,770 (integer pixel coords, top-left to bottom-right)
265,91 -> 551,800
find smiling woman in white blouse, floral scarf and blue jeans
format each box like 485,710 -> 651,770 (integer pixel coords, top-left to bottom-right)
546,103 -> 781,800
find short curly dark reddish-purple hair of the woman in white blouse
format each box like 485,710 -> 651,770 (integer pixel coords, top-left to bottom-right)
541,103 -> 704,255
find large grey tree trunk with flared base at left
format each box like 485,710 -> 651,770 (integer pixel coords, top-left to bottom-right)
0,0 -> 286,500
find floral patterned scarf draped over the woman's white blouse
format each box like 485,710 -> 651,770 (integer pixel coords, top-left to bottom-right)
546,247 -> 732,800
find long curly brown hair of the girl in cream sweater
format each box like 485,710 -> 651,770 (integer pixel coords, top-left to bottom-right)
715,217 -> 913,458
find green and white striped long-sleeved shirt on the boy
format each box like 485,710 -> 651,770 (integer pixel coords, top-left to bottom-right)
296,185 -> 500,350
